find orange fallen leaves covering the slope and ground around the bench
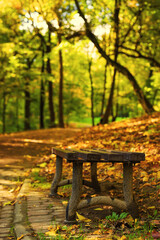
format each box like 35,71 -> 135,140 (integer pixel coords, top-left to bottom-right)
33,113 -> 160,239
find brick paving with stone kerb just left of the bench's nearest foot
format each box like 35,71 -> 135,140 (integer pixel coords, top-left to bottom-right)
13,179 -> 65,240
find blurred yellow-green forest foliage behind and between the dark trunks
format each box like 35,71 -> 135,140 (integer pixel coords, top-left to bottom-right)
0,0 -> 160,132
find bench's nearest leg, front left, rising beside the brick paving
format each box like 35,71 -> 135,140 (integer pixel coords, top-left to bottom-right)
65,162 -> 83,224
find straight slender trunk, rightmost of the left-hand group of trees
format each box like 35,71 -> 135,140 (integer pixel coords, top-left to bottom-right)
58,33 -> 64,128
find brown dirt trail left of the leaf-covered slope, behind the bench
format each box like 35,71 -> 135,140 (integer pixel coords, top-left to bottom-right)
0,128 -> 81,205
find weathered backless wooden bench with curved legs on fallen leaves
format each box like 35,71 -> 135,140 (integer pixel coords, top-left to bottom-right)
50,148 -> 145,224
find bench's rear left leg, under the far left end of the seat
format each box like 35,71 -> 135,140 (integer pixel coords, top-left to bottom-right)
50,156 -> 63,197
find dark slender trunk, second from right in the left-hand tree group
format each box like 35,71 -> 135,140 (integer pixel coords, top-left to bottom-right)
47,30 -> 55,127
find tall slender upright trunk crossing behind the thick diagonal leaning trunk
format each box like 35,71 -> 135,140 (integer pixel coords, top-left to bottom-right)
102,0 -> 121,124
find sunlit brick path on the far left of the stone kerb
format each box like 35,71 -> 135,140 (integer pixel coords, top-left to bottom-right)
0,162 -> 27,240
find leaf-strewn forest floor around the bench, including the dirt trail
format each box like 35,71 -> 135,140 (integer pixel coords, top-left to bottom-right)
0,113 -> 160,240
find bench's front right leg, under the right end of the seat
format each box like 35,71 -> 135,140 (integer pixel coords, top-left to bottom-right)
123,163 -> 139,219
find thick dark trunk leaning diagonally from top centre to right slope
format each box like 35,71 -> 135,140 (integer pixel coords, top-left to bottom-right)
75,0 -> 155,114
